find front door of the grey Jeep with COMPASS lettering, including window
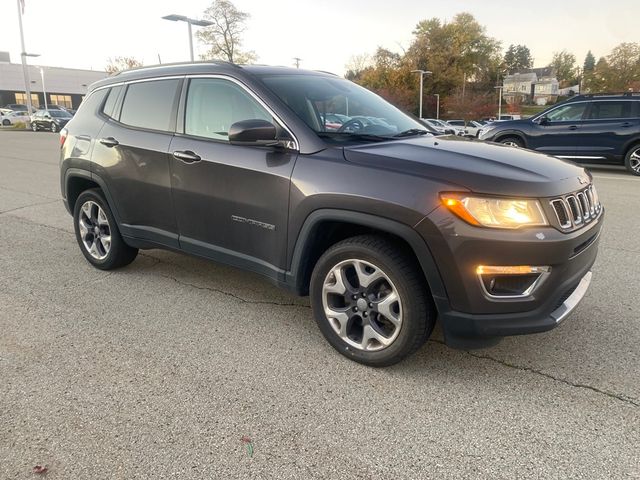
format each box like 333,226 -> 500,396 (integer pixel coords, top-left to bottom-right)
170,78 -> 297,276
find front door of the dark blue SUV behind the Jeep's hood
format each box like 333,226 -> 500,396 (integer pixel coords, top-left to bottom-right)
529,102 -> 589,157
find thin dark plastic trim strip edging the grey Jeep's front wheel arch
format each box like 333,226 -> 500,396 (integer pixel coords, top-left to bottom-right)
284,209 -> 449,316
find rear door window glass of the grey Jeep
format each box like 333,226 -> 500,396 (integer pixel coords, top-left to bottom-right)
120,79 -> 179,131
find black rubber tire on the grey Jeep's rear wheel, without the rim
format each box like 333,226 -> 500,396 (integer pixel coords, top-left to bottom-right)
73,188 -> 138,270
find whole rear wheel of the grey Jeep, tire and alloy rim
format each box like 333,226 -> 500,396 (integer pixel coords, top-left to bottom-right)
73,189 -> 138,270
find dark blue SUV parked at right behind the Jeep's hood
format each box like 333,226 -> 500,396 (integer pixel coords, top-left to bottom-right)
480,92 -> 640,175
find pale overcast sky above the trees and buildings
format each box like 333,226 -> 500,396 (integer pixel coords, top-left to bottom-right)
0,0 -> 640,74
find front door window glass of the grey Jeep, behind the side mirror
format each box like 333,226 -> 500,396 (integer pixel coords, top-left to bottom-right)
184,78 -> 276,141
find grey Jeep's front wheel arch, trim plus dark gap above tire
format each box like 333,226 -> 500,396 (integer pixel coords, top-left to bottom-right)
285,209 -> 446,304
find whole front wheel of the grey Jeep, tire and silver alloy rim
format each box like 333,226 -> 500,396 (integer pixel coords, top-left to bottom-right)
310,235 -> 435,367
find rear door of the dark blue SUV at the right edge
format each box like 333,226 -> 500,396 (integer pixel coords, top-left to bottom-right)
576,99 -> 640,161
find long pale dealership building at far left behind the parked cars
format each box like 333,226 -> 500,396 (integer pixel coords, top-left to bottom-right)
0,52 -> 109,109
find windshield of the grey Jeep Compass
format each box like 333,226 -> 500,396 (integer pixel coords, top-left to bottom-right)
262,75 -> 428,140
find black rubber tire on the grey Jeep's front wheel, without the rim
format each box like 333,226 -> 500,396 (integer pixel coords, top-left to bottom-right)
310,235 -> 436,367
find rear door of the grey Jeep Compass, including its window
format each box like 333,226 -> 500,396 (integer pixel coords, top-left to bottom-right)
92,78 -> 183,247
